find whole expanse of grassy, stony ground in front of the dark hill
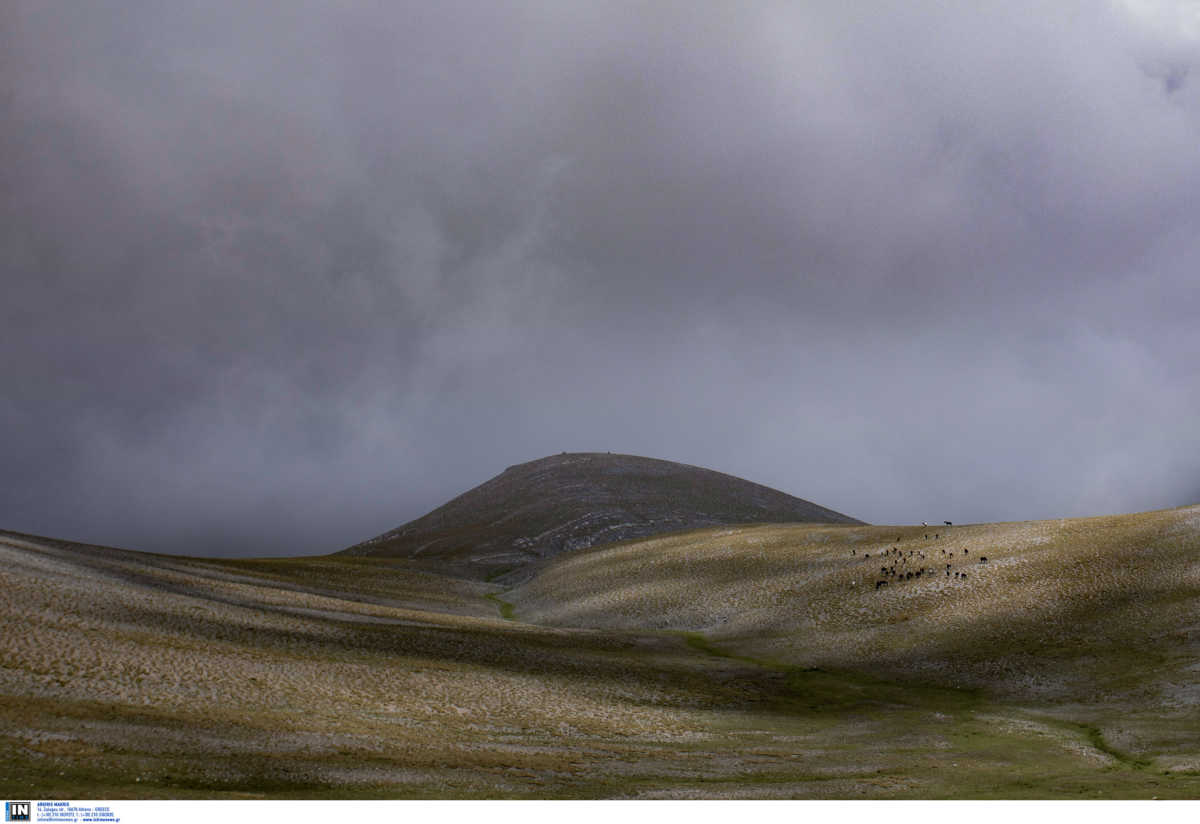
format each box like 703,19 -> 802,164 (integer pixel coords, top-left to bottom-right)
0,507 -> 1200,798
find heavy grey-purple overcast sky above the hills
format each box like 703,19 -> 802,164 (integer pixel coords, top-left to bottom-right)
0,0 -> 1200,555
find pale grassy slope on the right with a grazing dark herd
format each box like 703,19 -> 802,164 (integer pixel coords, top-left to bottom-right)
505,507 -> 1200,710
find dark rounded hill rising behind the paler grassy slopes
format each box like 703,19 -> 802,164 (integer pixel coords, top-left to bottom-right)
343,452 -> 862,576
